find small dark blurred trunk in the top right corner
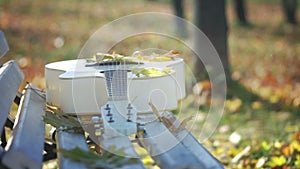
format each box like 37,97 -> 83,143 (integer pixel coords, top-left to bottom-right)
281,0 -> 297,25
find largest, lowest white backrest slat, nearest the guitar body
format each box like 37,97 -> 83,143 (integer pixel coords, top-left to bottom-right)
2,85 -> 45,169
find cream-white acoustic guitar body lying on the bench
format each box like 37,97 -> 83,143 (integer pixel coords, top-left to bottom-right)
45,58 -> 185,115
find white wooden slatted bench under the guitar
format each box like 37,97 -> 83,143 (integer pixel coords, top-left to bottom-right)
0,31 -> 223,169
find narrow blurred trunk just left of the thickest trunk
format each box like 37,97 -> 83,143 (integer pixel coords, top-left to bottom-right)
172,0 -> 187,38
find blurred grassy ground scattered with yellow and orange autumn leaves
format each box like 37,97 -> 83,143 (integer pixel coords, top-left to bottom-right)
0,0 -> 300,169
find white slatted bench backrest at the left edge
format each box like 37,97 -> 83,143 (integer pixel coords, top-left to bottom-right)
0,31 -> 45,169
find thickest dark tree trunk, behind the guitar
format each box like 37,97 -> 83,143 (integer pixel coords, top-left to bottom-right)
194,0 -> 230,79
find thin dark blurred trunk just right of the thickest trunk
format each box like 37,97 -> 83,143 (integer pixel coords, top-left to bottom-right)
234,0 -> 249,26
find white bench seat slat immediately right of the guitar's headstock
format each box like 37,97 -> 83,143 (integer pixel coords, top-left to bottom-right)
139,121 -> 203,169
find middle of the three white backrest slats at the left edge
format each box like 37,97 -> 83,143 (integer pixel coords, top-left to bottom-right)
0,61 -> 24,135
